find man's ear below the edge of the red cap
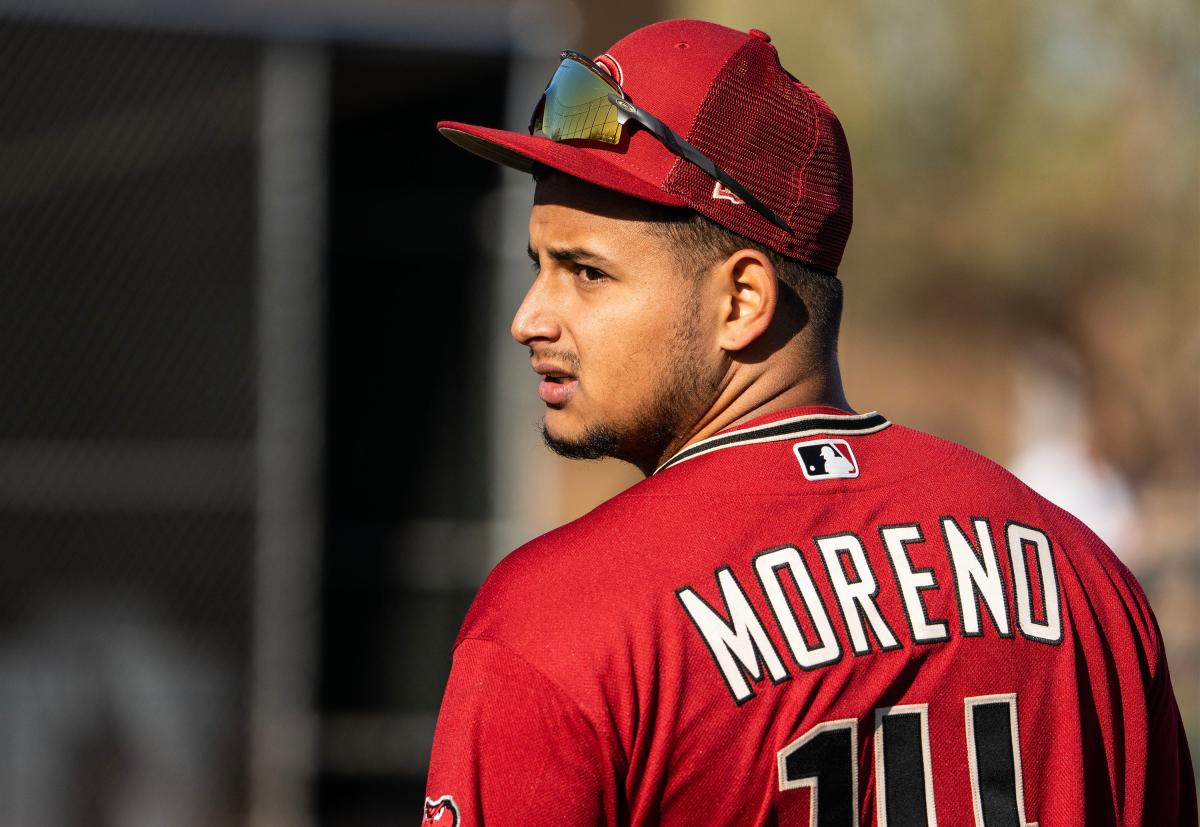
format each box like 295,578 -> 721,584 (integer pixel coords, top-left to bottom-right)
713,248 -> 779,352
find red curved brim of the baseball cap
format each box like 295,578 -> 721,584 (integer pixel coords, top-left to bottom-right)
438,121 -> 688,206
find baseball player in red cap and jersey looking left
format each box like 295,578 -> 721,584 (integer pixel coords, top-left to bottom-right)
425,20 -> 1195,827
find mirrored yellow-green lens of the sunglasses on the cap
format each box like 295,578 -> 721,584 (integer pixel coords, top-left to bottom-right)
538,59 -> 620,144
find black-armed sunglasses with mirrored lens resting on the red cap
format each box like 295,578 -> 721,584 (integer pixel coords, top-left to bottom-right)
529,49 -> 792,235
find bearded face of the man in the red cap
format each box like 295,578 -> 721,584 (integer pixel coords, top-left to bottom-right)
512,174 -> 722,471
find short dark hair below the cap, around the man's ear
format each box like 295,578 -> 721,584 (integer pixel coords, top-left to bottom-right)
648,208 -> 842,359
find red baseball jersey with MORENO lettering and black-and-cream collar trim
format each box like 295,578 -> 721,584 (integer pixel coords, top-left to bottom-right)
425,408 -> 1196,827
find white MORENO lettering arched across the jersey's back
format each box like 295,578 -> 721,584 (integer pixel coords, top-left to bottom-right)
676,517 -> 1062,703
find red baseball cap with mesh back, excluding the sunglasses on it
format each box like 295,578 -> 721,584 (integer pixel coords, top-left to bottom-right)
438,20 -> 852,274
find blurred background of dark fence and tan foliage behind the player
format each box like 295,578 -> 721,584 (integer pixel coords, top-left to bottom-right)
0,0 -> 1200,827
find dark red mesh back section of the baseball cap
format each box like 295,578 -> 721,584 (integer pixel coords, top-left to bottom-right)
662,37 -> 852,272
